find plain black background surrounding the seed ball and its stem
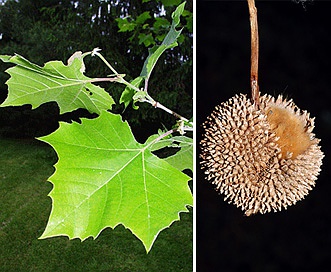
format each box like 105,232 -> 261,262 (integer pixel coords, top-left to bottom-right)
196,1 -> 331,272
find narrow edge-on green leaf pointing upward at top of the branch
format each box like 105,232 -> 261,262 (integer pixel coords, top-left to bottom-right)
140,2 -> 185,79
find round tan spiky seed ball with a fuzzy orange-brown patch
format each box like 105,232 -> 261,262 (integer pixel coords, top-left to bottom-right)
200,94 -> 324,215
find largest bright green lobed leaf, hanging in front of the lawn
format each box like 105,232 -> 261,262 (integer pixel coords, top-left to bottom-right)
40,111 -> 192,252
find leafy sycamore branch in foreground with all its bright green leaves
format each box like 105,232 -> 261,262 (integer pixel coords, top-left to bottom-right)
0,3 -> 193,252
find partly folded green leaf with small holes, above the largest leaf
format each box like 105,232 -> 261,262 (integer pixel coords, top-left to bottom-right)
0,52 -> 114,114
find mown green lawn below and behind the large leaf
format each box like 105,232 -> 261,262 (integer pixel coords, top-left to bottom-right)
0,139 -> 193,272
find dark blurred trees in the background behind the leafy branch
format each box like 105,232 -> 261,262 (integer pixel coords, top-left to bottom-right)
0,0 -> 193,140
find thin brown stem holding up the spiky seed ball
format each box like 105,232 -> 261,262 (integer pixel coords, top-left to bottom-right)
247,0 -> 260,107
